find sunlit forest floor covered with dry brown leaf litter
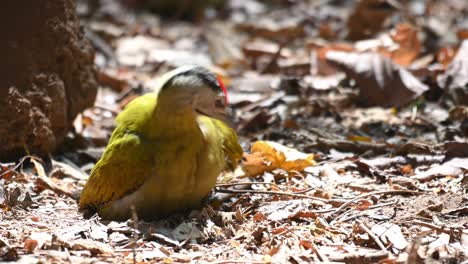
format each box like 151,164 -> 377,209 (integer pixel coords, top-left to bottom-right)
0,0 -> 468,263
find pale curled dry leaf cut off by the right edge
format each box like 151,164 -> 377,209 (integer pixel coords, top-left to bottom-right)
437,40 -> 468,105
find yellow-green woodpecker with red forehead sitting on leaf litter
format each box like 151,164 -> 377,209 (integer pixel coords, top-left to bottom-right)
79,65 -> 243,221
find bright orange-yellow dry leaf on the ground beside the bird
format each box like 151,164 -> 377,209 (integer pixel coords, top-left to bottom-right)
243,141 -> 316,176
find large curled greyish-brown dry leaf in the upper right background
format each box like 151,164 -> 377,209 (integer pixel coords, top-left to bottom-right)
326,51 -> 428,107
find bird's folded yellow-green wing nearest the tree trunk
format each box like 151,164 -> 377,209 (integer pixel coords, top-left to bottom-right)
80,93 -> 156,209
